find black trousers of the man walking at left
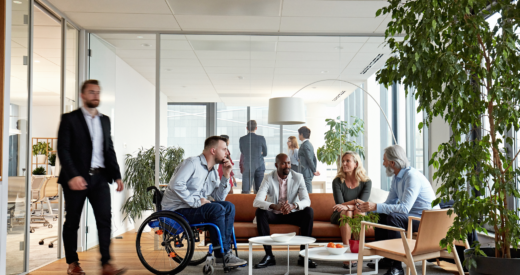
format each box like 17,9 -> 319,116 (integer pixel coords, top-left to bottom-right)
62,174 -> 112,265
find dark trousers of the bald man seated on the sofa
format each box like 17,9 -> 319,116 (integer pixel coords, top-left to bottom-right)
256,207 -> 314,256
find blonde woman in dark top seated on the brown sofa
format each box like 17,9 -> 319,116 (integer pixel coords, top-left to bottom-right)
330,151 -> 372,269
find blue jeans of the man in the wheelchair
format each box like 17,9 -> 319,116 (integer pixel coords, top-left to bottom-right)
175,201 -> 235,258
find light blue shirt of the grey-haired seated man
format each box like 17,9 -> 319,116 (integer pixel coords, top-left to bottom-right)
376,167 -> 440,217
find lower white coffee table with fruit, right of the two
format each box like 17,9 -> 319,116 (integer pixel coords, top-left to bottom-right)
300,246 -> 383,275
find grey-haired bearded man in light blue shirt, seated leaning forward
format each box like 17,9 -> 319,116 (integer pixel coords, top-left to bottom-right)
357,145 -> 439,275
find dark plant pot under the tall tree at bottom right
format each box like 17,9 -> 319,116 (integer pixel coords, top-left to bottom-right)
464,247 -> 520,275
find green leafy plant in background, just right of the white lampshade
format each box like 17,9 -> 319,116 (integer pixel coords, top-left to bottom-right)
318,117 -> 365,169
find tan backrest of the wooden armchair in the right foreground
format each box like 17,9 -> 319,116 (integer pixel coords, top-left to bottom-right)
412,209 -> 455,255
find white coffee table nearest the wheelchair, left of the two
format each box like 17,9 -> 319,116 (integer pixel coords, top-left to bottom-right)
249,236 -> 316,275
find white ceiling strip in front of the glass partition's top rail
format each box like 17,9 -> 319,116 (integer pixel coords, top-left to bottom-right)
49,0 -> 387,34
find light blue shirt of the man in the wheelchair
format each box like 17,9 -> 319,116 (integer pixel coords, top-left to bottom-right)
161,154 -> 231,211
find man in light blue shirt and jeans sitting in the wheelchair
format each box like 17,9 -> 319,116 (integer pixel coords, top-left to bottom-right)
161,136 -> 247,266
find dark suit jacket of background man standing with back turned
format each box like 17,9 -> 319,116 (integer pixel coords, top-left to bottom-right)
239,133 -> 267,171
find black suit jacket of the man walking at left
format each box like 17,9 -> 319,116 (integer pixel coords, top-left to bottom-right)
58,109 -> 121,187
